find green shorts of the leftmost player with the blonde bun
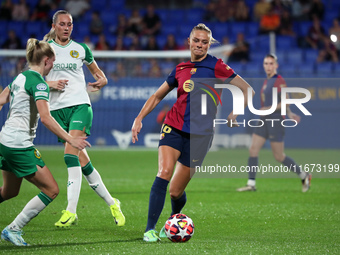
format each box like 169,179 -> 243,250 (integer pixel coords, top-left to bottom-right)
0,143 -> 45,178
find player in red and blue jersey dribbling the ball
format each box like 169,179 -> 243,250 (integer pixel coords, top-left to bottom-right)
132,24 -> 251,242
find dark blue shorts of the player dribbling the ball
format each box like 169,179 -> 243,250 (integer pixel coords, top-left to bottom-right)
159,124 -> 213,168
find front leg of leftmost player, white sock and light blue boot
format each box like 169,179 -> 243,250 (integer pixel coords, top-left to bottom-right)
1,166 -> 59,246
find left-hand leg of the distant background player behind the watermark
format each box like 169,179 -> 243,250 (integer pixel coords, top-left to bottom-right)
237,133 -> 266,192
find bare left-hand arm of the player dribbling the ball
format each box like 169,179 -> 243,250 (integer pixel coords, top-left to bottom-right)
131,81 -> 173,143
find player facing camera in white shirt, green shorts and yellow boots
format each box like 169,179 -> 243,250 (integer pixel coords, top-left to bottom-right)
44,10 -> 125,228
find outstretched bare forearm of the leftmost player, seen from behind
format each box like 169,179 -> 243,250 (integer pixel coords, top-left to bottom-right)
36,99 -> 91,150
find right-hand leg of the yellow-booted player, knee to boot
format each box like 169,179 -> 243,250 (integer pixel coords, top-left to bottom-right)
79,149 -> 125,226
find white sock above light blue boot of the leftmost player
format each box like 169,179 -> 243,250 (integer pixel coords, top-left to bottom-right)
8,196 -> 46,231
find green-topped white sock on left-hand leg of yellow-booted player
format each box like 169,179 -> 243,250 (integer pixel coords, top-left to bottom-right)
64,154 -> 82,213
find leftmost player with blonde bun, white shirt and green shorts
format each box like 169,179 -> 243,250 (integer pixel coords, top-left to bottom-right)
0,38 -> 90,246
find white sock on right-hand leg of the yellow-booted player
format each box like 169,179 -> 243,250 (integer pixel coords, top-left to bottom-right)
84,169 -> 115,206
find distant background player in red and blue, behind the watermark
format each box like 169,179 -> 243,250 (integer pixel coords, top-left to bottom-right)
237,54 -> 312,192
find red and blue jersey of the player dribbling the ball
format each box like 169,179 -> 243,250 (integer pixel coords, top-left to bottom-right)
164,54 -> 237,135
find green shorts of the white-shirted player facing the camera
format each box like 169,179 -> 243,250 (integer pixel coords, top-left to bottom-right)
51,104 -> 93,143
